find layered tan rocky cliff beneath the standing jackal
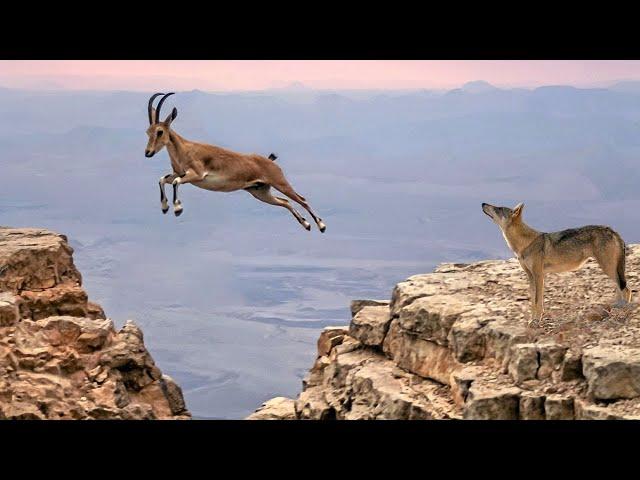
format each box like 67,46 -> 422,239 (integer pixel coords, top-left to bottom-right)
248,245 -> 640,420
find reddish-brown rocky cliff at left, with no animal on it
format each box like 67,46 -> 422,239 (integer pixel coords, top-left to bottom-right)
0,227 -> 191,419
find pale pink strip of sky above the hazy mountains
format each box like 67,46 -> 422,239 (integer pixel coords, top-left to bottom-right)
0,60 -> 640,91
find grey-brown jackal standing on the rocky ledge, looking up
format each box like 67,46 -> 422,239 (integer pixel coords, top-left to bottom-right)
482,203 -> 631,325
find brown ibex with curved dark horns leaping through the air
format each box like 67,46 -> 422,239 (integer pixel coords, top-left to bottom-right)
144,93 -> 327,232
